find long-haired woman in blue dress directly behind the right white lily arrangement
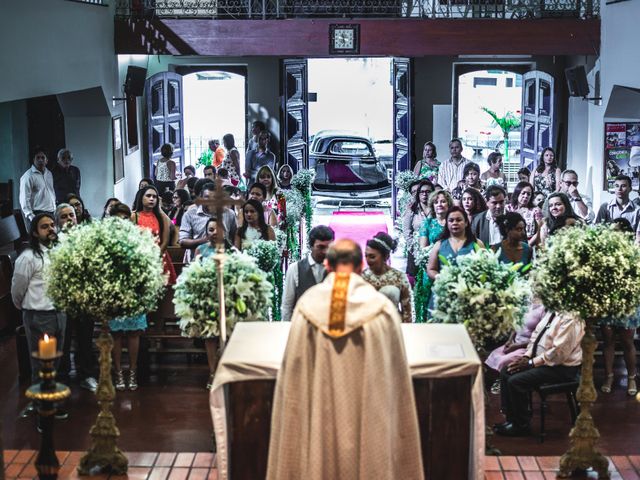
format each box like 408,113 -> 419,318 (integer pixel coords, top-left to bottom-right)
427,207 -> 484,320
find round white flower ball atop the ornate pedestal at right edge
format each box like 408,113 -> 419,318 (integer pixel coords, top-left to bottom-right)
532,226 -> 640,320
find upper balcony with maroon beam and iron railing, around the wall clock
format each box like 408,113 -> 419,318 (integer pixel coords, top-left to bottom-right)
115,0 -> 600,57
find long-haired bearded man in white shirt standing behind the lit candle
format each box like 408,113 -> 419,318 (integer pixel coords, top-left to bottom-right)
11,213 -> 67,383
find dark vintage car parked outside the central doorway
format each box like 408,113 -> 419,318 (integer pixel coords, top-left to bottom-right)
309,132 -> 391,199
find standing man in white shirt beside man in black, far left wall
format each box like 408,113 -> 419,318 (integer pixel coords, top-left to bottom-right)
20,150 -> 56,226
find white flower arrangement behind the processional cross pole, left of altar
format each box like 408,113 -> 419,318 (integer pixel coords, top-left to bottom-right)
173,253 -> 273,338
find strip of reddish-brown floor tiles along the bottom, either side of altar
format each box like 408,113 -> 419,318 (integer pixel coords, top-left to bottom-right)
4,450 -> 640,480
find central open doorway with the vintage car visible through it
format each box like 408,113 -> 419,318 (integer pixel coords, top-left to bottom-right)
308,58 -> 393,210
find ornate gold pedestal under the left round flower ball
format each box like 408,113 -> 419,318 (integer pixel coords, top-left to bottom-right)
78,320 -> 129,475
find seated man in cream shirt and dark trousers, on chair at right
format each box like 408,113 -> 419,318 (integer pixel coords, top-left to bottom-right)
494,312 -> 584,437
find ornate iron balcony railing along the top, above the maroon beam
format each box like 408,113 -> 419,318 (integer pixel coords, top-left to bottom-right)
116,0 -> 600,20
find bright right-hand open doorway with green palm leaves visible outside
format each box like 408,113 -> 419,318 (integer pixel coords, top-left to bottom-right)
455,65 -> 528,184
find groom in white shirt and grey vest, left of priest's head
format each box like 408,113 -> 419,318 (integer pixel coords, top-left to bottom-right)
281,225 -> 334,322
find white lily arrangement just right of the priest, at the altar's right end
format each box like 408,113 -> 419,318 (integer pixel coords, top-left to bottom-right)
433,247 -> 529,351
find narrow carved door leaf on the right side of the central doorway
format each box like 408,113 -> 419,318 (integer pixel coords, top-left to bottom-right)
391,58 -> 414,218
